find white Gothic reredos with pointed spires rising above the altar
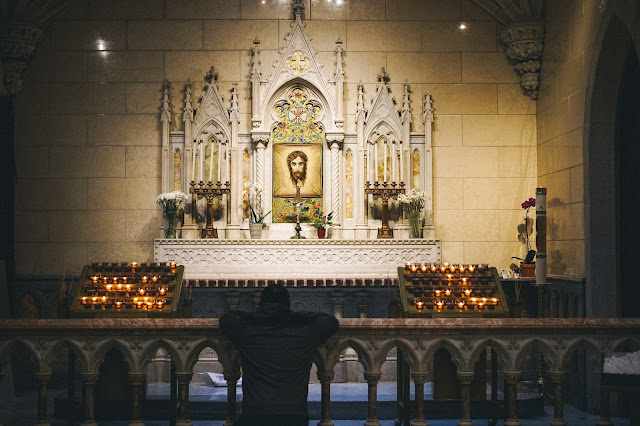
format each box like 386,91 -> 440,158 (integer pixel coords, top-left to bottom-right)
155,1 -> 440,280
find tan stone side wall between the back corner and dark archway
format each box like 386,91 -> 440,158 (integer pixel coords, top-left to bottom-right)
537,1 -> 604,276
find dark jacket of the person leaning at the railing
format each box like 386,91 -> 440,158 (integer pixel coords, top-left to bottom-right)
220,303 -> 338,417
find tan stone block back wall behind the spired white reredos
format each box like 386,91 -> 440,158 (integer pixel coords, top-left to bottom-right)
15,0 -> 536,275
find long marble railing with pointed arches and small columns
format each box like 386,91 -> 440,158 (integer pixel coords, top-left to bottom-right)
0,318 -> 640,426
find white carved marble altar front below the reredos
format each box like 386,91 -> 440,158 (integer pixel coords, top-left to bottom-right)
154,239 -> 440,279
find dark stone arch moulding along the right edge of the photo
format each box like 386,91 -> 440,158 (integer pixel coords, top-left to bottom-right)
583,0 -> 640,317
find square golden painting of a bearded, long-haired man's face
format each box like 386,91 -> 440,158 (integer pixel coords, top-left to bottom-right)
273,144 -> 322,197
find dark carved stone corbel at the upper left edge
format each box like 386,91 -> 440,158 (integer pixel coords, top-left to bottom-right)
0,22 -> 42,96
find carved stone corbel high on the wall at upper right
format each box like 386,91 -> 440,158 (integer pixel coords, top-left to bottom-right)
500,22 -> 544,100
